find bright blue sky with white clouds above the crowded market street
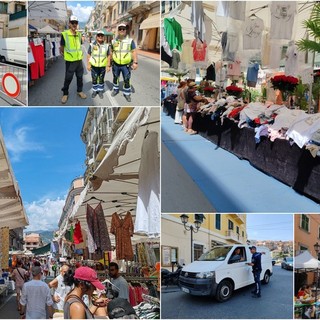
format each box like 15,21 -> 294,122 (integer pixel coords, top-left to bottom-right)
0,107 -> 87,231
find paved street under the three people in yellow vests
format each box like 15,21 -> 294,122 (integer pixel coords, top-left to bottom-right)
28,44 -> 160,106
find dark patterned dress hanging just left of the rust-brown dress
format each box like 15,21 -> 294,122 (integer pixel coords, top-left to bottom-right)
86,202 -> 111,252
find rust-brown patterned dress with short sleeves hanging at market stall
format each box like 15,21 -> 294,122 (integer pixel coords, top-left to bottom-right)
110,211 -> 134,261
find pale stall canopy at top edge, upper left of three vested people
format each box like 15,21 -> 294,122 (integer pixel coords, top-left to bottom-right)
28,1 -> 68,21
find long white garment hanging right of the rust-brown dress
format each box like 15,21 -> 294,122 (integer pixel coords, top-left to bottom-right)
134,131 -> 161,237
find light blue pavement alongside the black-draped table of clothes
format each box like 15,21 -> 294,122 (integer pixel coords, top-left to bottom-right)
161,112 -> 320,213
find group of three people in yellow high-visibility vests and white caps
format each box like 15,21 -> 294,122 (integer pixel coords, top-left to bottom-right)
60,16 -> 138,104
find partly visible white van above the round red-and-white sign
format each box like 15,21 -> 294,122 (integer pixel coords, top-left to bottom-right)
0,37 -> 27,66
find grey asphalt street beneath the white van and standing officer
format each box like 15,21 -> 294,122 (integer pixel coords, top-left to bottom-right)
161,265 -> 293,319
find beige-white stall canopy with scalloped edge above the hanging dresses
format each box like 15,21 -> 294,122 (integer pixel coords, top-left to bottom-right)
91,107 -> 160,190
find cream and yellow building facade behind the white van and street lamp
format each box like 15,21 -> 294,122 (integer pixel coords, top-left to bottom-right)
161,214 -> 247,268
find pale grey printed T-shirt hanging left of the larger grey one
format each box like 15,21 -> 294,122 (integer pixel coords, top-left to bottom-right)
243,17 -> 264,50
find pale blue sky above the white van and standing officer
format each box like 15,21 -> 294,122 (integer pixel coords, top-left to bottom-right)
247,213 -> 293,241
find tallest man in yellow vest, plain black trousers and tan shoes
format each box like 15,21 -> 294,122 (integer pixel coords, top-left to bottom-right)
60,16 -> 87,103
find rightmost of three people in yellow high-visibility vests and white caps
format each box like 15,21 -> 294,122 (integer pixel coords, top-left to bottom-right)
107,23 -> 138,102
